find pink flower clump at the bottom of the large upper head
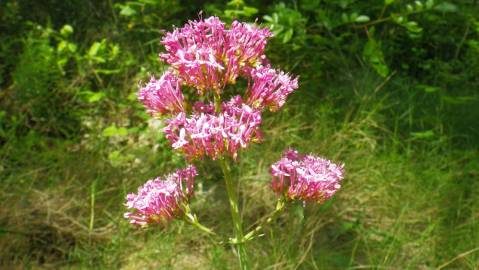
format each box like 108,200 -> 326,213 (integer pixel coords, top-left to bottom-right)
163,97 -> 261,159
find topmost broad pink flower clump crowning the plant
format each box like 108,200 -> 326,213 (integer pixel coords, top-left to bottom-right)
160,17 -> 271,94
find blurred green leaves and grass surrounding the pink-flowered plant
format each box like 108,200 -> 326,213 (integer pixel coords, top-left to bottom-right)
0,0 -> 479,269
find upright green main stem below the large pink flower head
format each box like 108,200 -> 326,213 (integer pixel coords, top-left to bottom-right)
219,157 -> 249,270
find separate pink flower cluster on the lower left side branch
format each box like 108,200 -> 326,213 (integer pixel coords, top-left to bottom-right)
124,165 -> 197,226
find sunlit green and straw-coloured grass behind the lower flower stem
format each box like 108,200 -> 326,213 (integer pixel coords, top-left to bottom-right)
0,67 -> 479,269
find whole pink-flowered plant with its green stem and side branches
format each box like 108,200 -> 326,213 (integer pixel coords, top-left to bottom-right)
125,17 -> 343,269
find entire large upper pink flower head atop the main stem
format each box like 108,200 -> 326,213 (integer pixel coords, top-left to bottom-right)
138,17 -> 298,160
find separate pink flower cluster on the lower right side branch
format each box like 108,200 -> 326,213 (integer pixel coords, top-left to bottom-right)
271,149 -> 344,203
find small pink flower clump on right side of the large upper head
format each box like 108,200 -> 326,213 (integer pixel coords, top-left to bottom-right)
247,66 -> 298,111
